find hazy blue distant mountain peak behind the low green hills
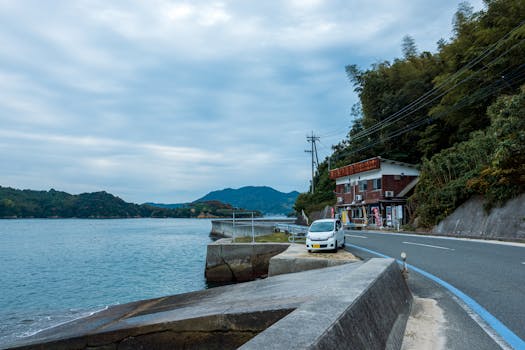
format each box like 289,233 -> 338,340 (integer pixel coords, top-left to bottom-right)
194,186 -> 299,215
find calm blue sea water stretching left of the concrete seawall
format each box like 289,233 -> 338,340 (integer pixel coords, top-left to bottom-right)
0,219 -> 211,347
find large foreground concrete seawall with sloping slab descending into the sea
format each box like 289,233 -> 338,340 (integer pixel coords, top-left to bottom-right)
6,259 -> 412,350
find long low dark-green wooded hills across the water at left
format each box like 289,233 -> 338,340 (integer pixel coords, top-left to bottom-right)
0,186 -> 254,218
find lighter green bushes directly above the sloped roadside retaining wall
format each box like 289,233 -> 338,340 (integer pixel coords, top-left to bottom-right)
412,86 -> 525,226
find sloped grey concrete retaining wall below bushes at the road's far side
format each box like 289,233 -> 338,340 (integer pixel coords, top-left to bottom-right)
432,194 -> 525,240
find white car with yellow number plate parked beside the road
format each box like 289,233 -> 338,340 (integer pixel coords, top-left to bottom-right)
306,219 -> 345,252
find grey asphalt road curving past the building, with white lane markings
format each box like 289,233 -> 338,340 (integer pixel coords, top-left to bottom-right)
346,231 -> 525,348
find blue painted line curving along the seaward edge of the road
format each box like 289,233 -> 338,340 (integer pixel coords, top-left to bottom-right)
345,243 -> 525,350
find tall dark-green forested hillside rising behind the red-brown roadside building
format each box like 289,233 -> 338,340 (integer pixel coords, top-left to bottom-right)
295,0 -> 525,227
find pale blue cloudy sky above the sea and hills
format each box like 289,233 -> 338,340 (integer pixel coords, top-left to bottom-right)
0,0 -> 483,203
